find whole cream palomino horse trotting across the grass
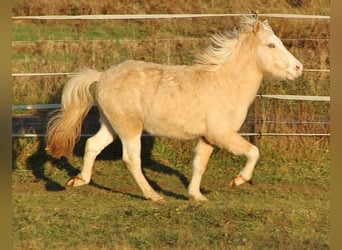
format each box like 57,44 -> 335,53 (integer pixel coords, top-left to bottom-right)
46,15 -> 303,201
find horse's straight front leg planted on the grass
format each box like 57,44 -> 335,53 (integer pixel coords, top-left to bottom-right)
188,138 -> 213,201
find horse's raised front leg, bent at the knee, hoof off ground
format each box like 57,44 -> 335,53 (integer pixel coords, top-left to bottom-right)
210,133 -> 259,188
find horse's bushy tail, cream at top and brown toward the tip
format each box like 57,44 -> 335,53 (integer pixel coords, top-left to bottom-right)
45,69 -> 102,158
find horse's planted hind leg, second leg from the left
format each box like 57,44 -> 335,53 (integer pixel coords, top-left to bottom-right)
121,134 -> 164,201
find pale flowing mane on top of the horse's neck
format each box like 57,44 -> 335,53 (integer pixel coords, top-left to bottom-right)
195,15 -> 273,65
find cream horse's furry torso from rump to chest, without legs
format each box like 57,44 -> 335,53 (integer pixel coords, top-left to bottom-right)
96,61 -> 255,141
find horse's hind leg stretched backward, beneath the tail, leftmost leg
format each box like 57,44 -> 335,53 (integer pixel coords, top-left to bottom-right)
66,120 -> 115,187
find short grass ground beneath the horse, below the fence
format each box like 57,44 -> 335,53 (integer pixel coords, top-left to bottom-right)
12,139 -> 330,249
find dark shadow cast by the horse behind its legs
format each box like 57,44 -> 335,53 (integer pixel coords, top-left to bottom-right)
26,136 -> 195,200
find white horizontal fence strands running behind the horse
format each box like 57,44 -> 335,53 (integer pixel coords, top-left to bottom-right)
12,13 -> 330,138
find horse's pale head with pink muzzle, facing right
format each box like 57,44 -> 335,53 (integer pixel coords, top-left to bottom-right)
253,20 -> 303,80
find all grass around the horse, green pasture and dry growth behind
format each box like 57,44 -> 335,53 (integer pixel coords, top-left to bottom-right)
12,0 -> 330,249
